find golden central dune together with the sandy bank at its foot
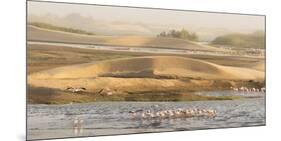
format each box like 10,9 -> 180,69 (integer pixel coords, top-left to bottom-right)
28,56 -> 264,93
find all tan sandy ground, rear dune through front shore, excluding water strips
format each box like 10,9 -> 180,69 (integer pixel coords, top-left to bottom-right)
27,26 -> 265,104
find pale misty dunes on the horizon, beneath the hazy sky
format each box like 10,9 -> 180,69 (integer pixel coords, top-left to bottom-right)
28,13 -> 253,41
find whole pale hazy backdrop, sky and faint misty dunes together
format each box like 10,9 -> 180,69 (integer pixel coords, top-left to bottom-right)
28,1 -> 265,40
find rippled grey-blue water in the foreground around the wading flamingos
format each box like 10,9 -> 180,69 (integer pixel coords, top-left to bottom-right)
27,92 -> 265,139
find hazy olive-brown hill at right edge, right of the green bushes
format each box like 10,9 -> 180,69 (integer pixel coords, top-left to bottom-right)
211,31 -> 265,48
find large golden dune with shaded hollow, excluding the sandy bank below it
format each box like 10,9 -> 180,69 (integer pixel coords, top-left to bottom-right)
30,56 -> 264,80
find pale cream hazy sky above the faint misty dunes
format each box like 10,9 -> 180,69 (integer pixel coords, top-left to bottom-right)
28,1 -> 264,36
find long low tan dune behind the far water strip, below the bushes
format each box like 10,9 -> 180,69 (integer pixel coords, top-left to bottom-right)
27,25 -> 223,51
